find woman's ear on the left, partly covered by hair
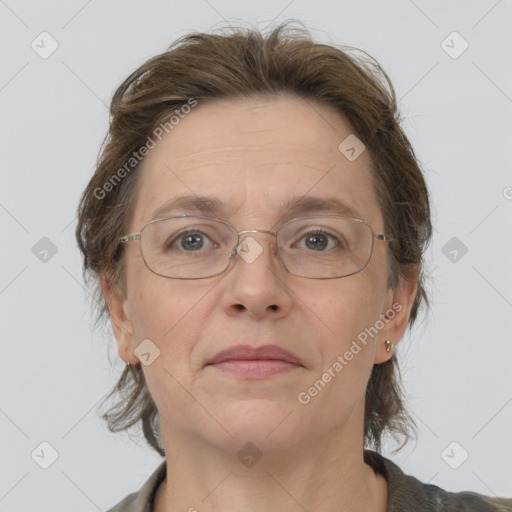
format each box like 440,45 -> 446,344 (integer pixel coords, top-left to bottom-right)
101,276 -> 139,364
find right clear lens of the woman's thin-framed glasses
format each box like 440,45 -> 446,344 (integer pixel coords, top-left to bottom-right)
277,217 -> 373,279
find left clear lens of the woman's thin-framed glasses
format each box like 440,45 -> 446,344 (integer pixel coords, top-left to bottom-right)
141,217 -> 237,279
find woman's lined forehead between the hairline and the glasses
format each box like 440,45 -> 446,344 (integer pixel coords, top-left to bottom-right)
133,96 -> 380,227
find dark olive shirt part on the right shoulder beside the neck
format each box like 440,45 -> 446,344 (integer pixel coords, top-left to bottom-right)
364,450 -> 512,512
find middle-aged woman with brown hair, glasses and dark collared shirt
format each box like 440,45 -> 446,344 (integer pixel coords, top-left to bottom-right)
77,25 -> 512,512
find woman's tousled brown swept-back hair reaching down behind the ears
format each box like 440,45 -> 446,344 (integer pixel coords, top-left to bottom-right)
76,22 -> 432,455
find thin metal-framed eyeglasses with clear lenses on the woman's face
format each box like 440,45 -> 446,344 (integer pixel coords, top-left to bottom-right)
119,215 -> 394,279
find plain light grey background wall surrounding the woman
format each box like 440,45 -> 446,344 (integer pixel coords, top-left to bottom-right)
0,0 -> 512,512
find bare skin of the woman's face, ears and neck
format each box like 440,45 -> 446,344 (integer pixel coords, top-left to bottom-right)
103,96 -> 416,512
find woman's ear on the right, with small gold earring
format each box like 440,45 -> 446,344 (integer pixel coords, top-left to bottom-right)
374,267 -> 419,364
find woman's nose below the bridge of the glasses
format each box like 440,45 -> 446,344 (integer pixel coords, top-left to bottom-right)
222,231 -> 292,319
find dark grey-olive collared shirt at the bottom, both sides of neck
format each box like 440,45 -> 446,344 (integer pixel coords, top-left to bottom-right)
107,450 -> 512,512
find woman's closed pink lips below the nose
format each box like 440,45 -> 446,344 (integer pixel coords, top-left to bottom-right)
205,345 -> 304,378
